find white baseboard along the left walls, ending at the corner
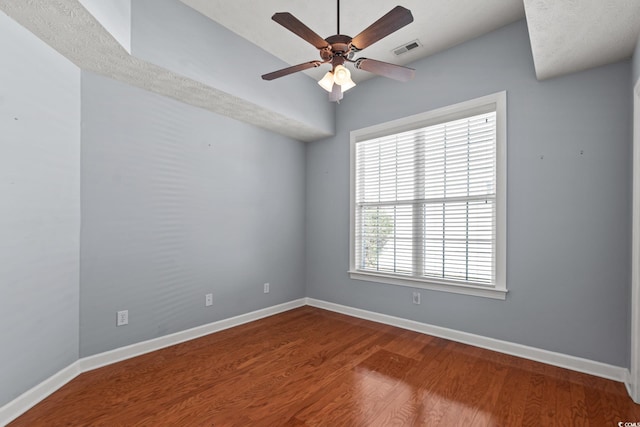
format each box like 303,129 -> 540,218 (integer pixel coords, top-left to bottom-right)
0,298 -> 306,426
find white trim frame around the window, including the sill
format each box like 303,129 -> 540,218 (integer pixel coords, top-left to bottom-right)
349,91 -> 507,300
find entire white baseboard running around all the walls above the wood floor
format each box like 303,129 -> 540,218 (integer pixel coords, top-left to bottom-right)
0,298 -> 633,426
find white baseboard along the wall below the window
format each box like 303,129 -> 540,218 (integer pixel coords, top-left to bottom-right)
306,298 -> 630,384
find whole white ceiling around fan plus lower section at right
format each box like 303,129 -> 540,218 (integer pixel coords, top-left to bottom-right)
180,0 -> 640,82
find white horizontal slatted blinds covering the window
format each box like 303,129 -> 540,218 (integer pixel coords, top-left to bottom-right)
353,111 -> 496,286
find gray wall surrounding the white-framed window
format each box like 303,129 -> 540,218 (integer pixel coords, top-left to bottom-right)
307,21 -> 631,366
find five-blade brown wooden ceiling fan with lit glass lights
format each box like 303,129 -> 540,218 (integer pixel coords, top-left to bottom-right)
262,0 -> 415,102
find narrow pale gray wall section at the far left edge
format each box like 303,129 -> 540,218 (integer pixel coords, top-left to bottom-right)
0,13 -> 80,407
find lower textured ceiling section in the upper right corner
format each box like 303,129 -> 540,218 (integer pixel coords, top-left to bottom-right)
524,0 -> 640,80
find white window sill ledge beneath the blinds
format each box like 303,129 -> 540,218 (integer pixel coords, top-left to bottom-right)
349,270 -> 507,300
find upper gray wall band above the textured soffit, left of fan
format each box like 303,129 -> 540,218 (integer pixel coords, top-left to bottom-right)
131,0 -> 335,140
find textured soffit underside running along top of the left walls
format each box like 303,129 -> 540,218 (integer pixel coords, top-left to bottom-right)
0,0 -> 329,141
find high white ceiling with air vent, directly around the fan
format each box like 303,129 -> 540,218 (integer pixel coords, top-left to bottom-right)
180,0 -> 524,82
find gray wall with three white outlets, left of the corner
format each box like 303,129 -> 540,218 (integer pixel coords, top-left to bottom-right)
80,72 -> 305,357
